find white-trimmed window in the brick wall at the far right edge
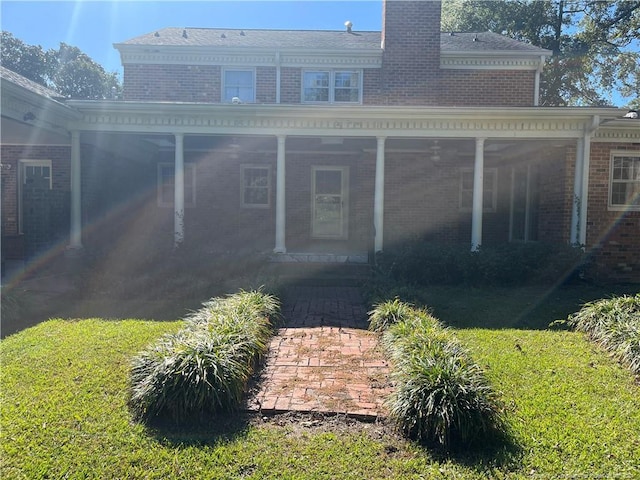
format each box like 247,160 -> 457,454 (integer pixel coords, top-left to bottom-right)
609,152 -> 640,210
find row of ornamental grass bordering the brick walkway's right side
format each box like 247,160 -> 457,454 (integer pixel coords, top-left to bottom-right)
372,304 -> 505,451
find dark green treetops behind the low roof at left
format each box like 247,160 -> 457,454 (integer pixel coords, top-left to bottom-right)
1,31 -> 121,99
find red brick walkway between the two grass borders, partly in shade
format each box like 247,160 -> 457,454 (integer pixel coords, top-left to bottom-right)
249,286 -> 390,417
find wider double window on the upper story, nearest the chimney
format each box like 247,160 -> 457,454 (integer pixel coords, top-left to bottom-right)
302,70 -> 362,103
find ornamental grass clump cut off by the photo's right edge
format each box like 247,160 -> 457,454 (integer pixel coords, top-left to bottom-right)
568,293 -> 640,375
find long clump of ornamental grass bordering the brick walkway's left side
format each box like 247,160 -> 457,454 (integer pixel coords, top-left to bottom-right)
129,291 -> 280,421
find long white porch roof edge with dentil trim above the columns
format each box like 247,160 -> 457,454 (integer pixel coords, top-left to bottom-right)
67,100 -> 640,142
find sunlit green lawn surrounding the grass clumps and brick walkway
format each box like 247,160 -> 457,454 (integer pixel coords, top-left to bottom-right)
0,319 -> 640,479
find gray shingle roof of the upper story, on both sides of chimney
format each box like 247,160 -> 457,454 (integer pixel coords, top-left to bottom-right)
116,27 -> 545,54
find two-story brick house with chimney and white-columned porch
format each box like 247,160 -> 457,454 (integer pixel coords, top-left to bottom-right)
2,1 -> 640,281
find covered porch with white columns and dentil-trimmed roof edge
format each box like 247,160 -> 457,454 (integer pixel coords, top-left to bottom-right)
69,101 -> 619,262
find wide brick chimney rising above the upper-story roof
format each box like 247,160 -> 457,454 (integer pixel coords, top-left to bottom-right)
382,0 -> 441,105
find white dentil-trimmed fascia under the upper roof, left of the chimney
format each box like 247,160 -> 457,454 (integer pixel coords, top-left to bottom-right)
114,44 -> 382,68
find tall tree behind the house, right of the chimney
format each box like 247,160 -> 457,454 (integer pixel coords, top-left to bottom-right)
442,0 -> 640,105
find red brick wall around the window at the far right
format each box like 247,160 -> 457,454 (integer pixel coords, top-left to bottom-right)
587,143 -> 640,282
